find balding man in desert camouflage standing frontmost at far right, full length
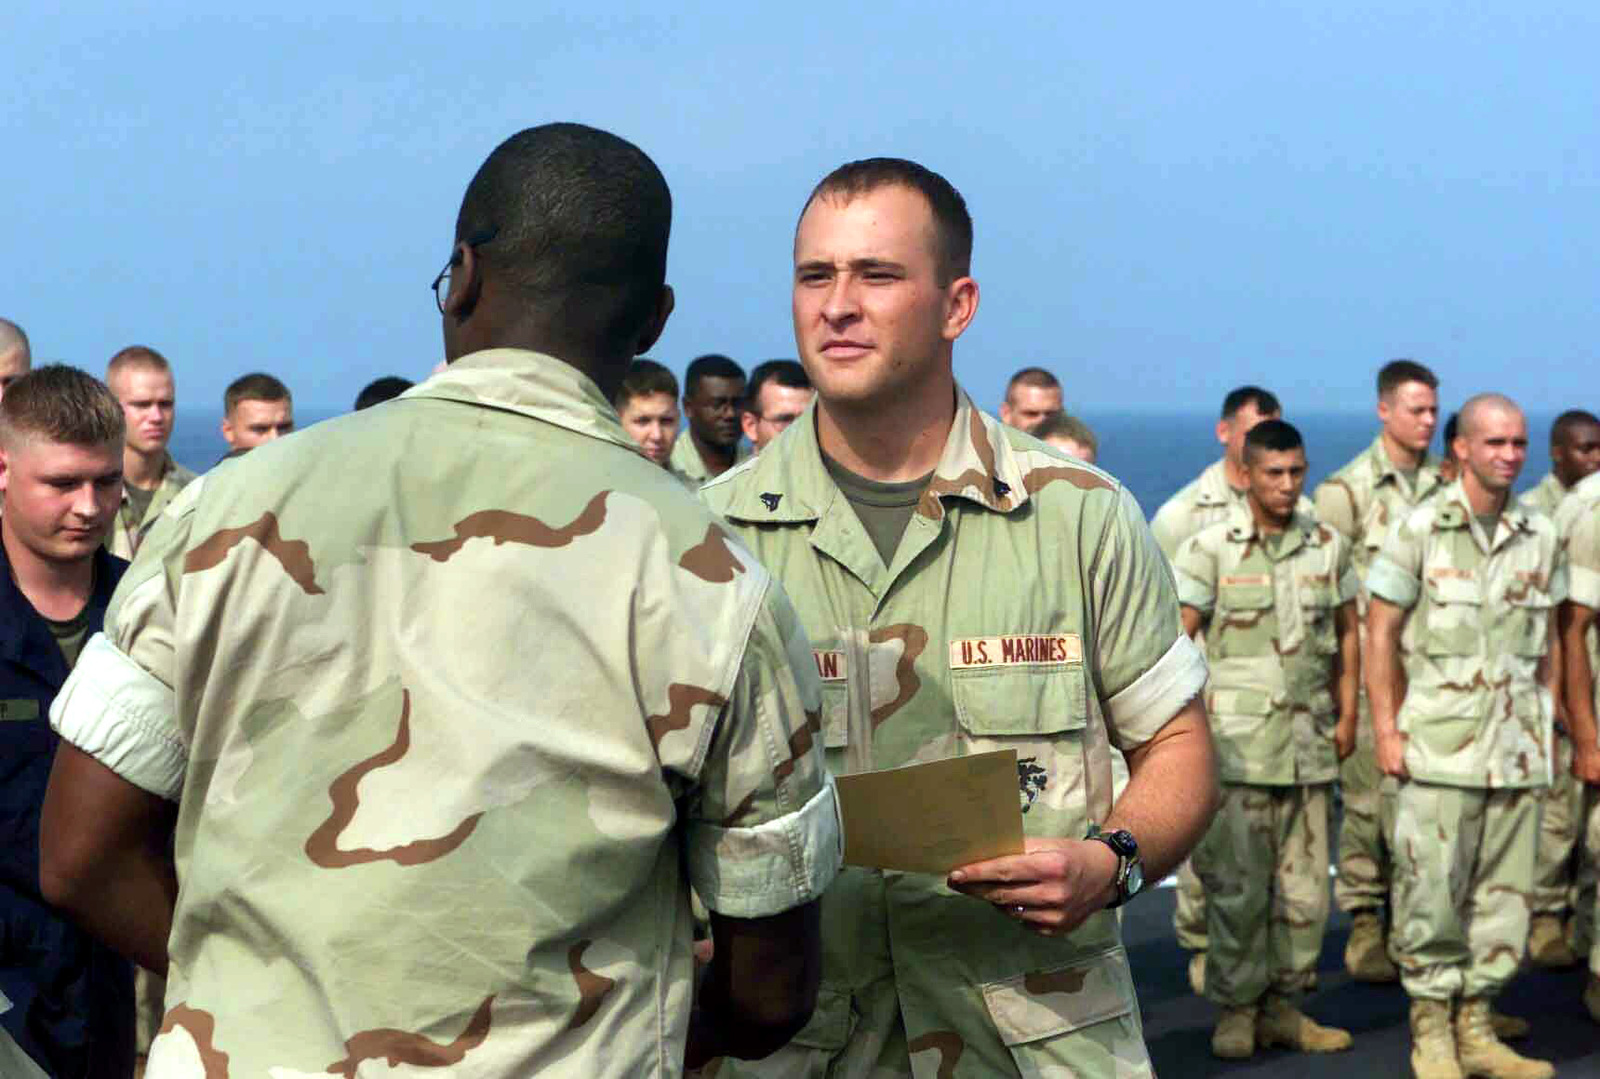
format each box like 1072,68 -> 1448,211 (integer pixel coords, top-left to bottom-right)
1366,394 -> 1566,1079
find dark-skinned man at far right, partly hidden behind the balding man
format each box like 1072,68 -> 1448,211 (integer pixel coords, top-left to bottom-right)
1522,410 -> 1600,967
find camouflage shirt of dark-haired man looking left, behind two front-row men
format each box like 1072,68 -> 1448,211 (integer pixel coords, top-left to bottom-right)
1312,435 -> 1445,618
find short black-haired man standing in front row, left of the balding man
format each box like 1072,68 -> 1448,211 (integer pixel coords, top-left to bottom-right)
1173,419 -> 1360,1058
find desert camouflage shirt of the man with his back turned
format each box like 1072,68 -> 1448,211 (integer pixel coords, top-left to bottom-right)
53,349 -> 840,1079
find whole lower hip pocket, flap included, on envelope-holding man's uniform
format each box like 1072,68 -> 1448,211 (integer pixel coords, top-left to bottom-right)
982,948 -> 1149,1076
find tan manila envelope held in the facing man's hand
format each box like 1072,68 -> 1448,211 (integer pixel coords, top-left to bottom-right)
835,749 -> 1022,874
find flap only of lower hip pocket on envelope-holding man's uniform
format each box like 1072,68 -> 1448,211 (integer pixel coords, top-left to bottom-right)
984,948 -> 1134,1047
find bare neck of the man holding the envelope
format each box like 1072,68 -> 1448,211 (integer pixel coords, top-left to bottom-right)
816,368 -> 955,483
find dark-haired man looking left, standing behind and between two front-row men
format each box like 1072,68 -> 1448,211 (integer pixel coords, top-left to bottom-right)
1315,360 -> 1448,981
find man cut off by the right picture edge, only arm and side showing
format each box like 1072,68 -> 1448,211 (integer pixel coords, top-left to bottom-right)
1557,472 -> 1600,1023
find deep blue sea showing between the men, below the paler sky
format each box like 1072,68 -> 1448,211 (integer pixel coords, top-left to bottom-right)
170,408 -> 1555,517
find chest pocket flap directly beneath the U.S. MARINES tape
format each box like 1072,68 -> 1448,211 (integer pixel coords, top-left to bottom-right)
950,664 -> 1088,736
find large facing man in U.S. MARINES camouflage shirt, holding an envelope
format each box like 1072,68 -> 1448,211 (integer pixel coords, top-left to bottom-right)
701,158 -> 1216,1079
